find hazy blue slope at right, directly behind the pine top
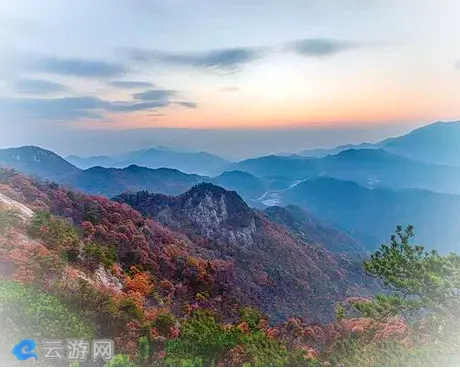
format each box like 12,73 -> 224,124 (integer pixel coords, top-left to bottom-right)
279,178 -> 460,252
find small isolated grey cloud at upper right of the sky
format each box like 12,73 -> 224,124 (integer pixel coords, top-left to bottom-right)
287,38 -> 361,57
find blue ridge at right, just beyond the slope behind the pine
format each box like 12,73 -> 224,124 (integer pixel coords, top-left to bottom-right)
234,149 -> 460,194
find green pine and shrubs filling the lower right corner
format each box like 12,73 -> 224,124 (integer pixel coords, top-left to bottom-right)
325,226 -> 460,366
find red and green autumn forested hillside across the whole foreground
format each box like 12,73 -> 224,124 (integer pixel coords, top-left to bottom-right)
0,170 -> 460,366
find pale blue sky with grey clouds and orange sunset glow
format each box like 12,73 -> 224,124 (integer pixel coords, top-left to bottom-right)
0,0 -> 460,158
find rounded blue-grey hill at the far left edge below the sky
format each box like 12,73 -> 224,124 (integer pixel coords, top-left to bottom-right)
0,146 -> 80,181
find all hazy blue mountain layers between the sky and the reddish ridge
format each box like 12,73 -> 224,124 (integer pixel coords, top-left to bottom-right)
0,123 -> 460,251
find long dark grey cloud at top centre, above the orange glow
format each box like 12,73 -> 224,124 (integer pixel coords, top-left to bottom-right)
129,47 -> 261,71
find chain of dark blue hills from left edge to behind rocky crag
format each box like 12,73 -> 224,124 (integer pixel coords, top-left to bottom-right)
0,146 -> 266,201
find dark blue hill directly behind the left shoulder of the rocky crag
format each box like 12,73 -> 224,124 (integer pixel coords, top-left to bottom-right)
61,165 -> 207,197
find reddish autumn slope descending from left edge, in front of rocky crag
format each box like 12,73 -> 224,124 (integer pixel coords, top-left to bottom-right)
0,169 -> 253,366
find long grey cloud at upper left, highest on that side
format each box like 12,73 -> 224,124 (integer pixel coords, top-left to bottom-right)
25,56 -> 126,79
